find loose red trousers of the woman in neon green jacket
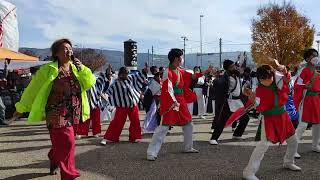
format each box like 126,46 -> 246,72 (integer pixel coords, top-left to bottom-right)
48,126 -> 80,180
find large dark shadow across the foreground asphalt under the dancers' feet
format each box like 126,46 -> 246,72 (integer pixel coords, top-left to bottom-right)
76,142 -> 320,179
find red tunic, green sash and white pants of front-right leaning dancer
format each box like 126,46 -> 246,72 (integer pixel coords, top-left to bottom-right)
243,72 -> 299,179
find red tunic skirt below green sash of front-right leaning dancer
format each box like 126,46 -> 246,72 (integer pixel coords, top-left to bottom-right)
264,112 -> 295,144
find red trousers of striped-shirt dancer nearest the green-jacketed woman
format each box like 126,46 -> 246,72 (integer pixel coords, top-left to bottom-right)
76,108 -> 101,136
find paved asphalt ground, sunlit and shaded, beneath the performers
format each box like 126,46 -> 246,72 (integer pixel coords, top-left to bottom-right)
0,113 -> 320,180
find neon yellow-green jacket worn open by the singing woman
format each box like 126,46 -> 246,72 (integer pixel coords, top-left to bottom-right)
16,61 -> 96,123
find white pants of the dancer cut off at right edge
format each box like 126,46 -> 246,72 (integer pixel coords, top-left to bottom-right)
296,121 -> 320,148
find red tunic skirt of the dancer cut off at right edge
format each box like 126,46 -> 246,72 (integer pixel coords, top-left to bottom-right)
302,96 -> 320,124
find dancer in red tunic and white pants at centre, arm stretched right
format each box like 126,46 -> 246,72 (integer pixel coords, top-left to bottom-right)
147,48 -> 213,161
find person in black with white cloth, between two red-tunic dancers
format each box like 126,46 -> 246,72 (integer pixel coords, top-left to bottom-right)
209,60 -> 249,145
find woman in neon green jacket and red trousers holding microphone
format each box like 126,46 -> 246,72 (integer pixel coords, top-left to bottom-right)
16,39 -> 95,180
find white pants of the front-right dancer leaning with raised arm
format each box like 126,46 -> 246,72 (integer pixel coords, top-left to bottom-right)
243,119 -> 298,176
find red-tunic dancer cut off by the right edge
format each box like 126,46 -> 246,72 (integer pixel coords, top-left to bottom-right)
293,49 -> 320,158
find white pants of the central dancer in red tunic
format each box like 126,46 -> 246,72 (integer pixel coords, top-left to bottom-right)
147,123 -> 193,157
